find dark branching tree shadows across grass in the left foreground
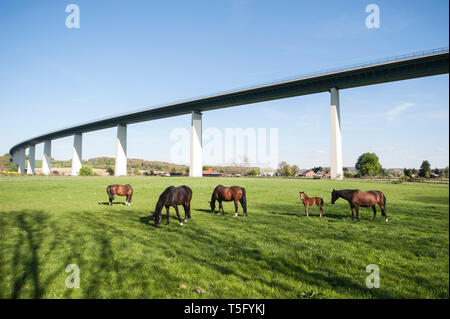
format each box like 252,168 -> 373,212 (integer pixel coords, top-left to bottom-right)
0,211 -> 414,298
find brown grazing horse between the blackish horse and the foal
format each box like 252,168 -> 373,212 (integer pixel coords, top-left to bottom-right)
209,185 -> 247,217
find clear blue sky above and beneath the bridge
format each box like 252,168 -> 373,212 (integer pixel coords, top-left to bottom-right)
0,0 -> 449,168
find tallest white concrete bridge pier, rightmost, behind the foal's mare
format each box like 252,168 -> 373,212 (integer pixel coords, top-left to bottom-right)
330,88 -> 344,179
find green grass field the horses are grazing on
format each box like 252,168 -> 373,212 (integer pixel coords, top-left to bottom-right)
0,177 -> 449,299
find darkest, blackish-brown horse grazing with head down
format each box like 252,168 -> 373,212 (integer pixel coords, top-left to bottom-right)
153,185 -> 192,227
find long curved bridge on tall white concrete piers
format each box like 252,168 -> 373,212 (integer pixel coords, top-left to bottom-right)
9,48 -> 449,179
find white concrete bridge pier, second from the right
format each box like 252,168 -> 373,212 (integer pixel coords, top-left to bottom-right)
189,111 -> 203,177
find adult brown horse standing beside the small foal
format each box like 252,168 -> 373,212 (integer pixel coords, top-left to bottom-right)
331,189 -> 388,223
